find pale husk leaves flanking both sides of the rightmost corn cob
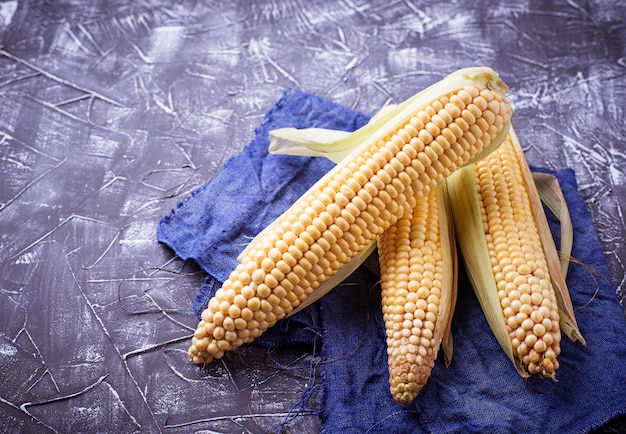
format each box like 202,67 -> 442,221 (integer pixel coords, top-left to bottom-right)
447,128 -> 585,377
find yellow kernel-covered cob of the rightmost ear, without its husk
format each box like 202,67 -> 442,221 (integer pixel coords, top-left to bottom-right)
474,136 -> 561,377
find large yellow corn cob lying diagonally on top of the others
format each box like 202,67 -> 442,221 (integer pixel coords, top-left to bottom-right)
189,68 -> 512,364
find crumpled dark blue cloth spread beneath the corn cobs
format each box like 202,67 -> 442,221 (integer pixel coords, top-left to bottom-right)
158,90 -> 626,433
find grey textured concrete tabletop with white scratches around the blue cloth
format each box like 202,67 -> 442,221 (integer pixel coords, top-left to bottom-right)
0,0 -> 626,432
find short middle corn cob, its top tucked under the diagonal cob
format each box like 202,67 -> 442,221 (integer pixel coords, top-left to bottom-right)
378,184 -> 456,404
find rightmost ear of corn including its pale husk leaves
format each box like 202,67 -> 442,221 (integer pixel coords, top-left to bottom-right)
447,130 -> 582,378
